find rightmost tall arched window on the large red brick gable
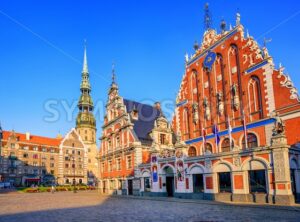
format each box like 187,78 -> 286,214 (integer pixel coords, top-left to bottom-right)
248,76 -> 263,118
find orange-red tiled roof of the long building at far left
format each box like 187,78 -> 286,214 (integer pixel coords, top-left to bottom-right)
3,131 -> 63,146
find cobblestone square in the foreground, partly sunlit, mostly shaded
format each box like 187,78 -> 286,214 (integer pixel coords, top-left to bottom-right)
0,191 -> 300,222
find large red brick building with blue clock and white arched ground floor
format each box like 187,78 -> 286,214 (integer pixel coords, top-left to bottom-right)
139,7 -> 300,204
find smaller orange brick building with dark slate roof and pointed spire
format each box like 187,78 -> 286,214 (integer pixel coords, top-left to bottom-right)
99,69 -> 173,195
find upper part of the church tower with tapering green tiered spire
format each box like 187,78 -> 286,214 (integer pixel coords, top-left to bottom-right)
76,44 -> 96,142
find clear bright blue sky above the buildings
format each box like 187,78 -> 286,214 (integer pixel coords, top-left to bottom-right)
0,0 -> 300,137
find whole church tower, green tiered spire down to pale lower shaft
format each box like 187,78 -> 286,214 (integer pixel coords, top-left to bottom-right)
76,43 -> 98,186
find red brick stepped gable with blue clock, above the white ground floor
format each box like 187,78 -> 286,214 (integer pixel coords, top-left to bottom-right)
173,9 -> 300,150
